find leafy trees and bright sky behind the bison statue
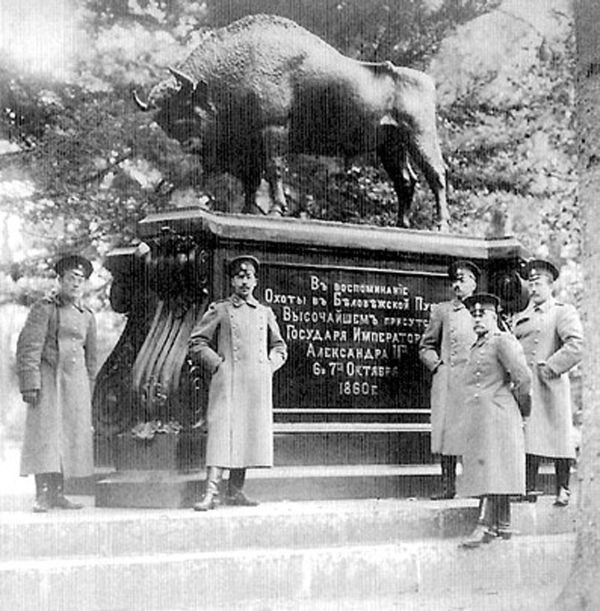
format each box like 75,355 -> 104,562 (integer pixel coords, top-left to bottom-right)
0,0 -> 581,440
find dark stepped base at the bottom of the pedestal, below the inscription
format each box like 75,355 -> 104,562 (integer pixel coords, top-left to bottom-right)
95,423 -> 439,508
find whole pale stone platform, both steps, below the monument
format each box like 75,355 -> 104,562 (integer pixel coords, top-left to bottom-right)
0,497 -> 574,611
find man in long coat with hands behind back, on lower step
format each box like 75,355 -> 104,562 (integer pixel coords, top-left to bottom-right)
458,293 -> 531,547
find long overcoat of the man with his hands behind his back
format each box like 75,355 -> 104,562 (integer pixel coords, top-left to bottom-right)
457,332 -> 531,496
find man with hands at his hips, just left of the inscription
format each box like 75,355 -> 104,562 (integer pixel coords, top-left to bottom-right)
189,255 -> 287,511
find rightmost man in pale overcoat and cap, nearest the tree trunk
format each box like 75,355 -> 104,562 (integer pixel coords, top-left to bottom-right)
513,259 -> 583,507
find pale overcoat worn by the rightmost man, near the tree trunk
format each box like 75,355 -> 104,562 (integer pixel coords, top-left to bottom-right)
513,298 -> 583,458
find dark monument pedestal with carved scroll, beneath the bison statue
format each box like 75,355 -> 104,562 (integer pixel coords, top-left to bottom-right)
94,210 -> 525,506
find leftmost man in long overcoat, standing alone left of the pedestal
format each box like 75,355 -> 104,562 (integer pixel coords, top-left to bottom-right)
17,255 -> 97,512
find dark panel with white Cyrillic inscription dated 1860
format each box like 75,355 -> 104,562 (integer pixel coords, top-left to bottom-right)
263,264 -> 447,411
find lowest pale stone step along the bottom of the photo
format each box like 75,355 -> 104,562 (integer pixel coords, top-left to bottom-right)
0,533 -> 575,611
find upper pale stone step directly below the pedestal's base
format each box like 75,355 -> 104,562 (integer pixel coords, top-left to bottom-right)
0,497 -> 575,560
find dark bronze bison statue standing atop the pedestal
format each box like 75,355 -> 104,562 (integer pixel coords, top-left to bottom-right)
134,15 -> 449,228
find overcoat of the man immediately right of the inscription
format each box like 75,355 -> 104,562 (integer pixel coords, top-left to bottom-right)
419,299 -> 476,455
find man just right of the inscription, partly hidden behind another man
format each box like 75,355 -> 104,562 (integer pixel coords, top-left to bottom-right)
419,260 -> 481,500
